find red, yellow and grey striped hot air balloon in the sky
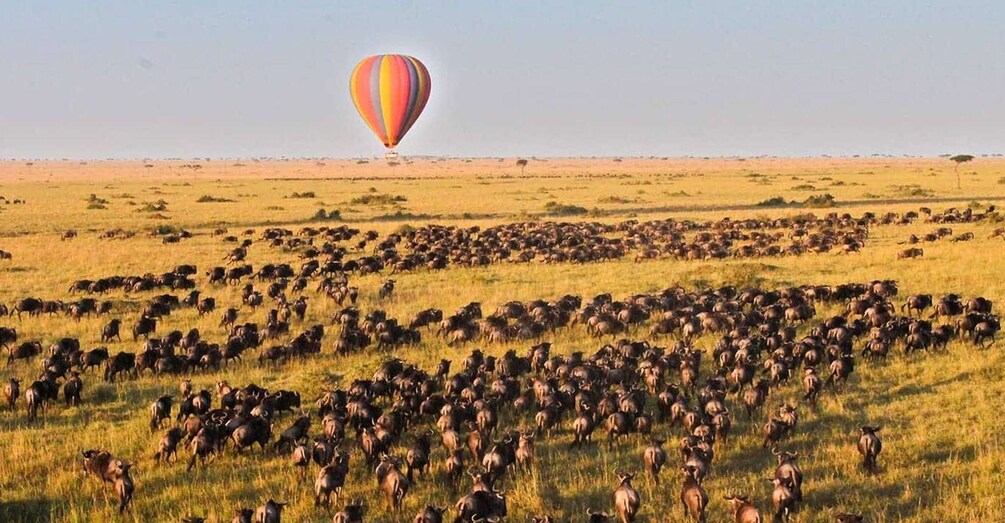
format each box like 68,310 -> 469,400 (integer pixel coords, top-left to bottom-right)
349,54 -> 429,149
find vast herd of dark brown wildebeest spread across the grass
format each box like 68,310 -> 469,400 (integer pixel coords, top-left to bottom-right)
0,206 -> 1000,523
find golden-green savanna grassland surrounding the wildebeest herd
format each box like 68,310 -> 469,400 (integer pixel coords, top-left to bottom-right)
0,158 -> 1005,523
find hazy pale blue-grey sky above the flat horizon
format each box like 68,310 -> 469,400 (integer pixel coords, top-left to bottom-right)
0,0 -> 1005,158
